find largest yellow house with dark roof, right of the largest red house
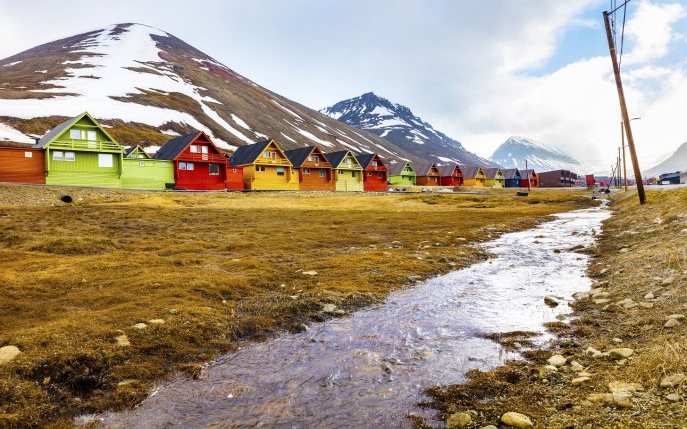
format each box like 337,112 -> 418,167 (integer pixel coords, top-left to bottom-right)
229,140 -> 299,191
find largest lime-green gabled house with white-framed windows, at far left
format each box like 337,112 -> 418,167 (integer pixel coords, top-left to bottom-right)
33,112 -> 124,188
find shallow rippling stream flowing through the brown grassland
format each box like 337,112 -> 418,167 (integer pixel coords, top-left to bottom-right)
98,203 -> 609,428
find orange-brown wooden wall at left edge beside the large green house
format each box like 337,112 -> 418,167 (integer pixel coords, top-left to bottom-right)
0,147 -> 45,184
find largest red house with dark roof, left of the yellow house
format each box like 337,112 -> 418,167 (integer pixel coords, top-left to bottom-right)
154,131 -> 232,191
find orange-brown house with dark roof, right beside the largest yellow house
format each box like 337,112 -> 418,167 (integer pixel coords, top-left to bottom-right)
284,146 -> 336,191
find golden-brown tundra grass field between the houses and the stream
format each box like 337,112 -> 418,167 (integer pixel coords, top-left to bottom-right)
0,186 -> 592,427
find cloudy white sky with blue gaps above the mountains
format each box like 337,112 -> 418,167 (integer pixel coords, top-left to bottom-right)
0,0 -> 687,169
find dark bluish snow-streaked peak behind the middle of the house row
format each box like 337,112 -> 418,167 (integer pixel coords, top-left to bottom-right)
320,92 -> 493,166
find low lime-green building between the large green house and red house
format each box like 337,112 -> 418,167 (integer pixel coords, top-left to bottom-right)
122,146 -> 174,190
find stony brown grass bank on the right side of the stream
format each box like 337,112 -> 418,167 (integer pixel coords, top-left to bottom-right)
420,189 -> 687,429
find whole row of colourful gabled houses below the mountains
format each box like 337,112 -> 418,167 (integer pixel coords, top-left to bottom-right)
0,112 -> 539,191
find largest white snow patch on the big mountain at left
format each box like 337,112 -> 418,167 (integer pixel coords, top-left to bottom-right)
0,24 -> 242,148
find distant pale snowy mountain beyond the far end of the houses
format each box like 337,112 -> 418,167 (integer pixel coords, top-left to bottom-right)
489,136 -> 588,174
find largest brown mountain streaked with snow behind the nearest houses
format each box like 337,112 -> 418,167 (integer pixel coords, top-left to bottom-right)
0,24 -> 419,161
